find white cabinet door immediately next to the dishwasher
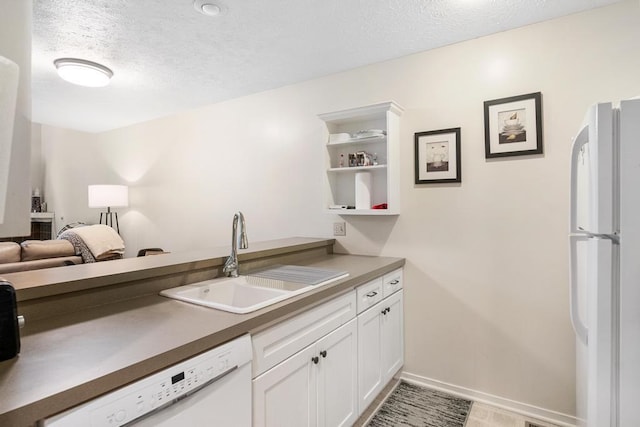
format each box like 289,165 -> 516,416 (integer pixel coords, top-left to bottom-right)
253,345 -> 317,427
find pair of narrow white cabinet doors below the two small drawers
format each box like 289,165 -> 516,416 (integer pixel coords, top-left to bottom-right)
358,290 -> 404,412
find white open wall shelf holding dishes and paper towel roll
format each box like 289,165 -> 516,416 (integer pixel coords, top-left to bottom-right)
318,101 -> 403,215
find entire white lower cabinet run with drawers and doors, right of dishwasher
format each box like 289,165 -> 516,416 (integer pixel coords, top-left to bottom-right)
252,268 -> 404,427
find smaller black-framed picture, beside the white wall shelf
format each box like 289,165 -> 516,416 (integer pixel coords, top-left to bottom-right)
414,128 -> 462,184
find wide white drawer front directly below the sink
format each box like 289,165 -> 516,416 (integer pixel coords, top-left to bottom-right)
252,291 -> 356,378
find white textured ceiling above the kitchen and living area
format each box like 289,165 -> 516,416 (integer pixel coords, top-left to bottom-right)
32,0 -> 617,132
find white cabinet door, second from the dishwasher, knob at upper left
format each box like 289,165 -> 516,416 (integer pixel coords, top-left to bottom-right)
316,319 -> 358,427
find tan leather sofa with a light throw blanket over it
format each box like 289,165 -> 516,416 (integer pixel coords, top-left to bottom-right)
0,224 -> 125,274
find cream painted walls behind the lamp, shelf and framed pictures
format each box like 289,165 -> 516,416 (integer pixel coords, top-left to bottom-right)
42,1 -> 640,419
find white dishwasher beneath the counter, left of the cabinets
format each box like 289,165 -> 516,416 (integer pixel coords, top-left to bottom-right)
40,335 -> 252,427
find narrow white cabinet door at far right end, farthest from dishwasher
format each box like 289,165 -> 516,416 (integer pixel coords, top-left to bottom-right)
382,290 -> 404,384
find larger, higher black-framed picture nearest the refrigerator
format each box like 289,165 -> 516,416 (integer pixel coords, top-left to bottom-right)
484,92 -> 542,159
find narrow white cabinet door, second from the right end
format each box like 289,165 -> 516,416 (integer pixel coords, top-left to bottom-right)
358,301 -> 384,413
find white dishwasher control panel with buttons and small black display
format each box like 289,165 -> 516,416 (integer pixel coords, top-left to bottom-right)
42,335 -> 252,427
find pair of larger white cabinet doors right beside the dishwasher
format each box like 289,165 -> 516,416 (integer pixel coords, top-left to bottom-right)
253,319 -> 358,427
